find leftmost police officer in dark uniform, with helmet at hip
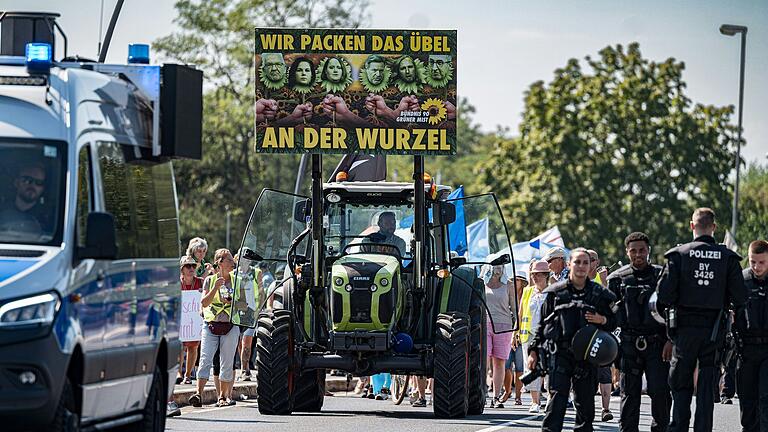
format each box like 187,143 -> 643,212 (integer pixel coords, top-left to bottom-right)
528,248 -> 616,431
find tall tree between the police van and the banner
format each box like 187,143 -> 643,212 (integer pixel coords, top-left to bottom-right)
153,0 -> 368,249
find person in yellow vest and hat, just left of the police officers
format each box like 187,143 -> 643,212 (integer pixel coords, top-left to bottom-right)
520,261 -> 549,414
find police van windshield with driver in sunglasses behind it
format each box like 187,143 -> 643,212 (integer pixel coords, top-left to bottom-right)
0,138 -> 66,245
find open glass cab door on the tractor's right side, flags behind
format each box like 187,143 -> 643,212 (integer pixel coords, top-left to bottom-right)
439,193 -> 519,332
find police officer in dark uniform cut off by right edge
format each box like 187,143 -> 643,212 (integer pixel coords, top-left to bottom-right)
735,240 -> 768,432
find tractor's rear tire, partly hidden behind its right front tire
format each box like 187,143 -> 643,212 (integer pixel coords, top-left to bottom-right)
467,296 -> 488,415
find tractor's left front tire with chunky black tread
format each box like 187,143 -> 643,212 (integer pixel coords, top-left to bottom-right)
256,310 -> 296,415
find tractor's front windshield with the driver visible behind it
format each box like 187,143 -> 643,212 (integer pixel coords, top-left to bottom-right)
325,202 -> 413,258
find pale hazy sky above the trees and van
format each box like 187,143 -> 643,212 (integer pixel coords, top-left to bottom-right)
6,0 -> 768,164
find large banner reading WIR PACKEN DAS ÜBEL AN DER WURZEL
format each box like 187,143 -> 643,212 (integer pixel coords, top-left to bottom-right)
255,28 -> 457,155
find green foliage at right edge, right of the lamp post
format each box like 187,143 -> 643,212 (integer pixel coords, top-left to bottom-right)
736,164 -> 768,248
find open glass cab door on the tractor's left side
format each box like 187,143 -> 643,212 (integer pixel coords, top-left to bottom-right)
232,189 -> 309,328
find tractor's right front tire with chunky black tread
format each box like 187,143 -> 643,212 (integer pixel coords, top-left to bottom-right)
433,312 -> 470,418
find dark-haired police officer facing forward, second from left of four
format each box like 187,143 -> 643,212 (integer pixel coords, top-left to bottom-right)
608,232 -> 672,432
